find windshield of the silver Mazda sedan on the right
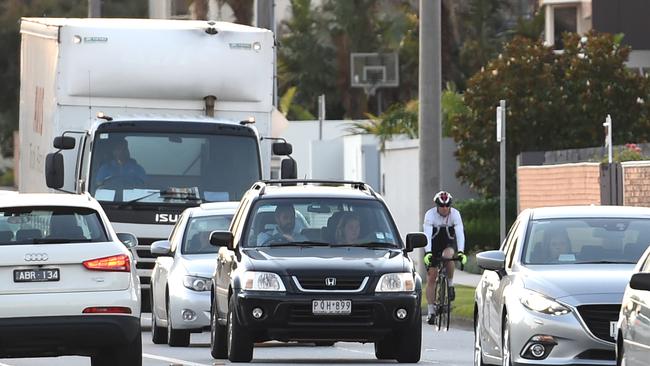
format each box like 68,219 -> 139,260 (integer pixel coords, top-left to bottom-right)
523,218 -> 650,265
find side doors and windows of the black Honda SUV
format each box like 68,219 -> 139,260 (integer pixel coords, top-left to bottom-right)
215,197 -> 250,319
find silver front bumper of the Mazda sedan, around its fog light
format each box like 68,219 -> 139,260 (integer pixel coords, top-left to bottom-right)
508,303 -> 616,366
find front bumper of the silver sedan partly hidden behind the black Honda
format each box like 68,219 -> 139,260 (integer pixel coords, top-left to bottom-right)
169,286 -> 210,330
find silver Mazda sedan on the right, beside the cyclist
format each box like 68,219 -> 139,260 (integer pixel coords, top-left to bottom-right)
474,206 -> 650,365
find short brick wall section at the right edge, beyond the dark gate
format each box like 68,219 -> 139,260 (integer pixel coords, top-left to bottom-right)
621,161 -> 650,207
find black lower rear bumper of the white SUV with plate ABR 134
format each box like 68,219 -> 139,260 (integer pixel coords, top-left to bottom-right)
0,315 -> 141,358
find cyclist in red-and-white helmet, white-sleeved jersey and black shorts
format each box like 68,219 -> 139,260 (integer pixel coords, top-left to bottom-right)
423,191 -> 467,324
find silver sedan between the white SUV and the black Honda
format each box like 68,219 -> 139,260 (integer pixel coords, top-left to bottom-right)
151,202 -> 239,347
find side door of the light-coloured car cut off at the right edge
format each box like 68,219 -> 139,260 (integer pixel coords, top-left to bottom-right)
625,256 -> 650,365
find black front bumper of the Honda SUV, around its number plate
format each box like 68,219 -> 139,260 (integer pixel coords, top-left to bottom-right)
230,291 -> 422,342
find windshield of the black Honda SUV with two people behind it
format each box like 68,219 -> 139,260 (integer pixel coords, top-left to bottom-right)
243,198 -> 401,248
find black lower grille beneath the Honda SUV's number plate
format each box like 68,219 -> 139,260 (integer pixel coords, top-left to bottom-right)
289,303 -> 374,326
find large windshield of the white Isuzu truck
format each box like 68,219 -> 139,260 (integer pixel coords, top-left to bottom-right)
89,132 -> 260,203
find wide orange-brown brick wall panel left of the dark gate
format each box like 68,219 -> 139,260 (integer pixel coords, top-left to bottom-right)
517,163 -> 600,212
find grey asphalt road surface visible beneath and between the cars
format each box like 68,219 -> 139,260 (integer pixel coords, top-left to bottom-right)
0,320 -> 474,366
